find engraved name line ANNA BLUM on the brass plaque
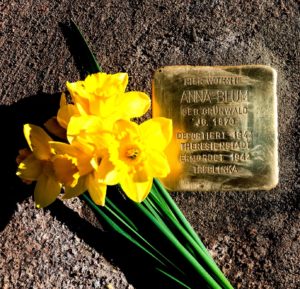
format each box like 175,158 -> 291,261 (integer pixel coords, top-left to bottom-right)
180,89 -> 248,104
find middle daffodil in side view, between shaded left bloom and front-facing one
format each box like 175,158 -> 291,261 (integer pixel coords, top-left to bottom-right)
50,115 -> 119,206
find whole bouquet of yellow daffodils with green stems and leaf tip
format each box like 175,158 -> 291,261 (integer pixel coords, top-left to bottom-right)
17,23 -> 233,289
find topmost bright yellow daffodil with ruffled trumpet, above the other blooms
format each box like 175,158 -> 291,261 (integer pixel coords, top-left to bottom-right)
57,72 -> 150,129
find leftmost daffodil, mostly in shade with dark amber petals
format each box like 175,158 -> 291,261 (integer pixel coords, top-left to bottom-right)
17,124 -> 79,207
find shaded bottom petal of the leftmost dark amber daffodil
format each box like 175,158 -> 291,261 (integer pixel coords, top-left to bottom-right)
34,174 -> 61,208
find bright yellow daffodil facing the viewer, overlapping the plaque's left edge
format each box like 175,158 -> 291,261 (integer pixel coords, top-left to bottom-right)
115,118 -> 172,202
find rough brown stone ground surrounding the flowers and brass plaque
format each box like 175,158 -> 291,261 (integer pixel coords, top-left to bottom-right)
0,0 -> 300,289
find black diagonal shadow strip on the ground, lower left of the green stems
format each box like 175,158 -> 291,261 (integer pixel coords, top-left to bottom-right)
48,200 -> 173,289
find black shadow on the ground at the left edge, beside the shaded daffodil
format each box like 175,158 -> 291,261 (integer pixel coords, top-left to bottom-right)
0,93 -> 59,231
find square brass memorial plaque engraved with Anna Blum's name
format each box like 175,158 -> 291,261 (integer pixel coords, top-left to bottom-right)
152,65 -> 278,191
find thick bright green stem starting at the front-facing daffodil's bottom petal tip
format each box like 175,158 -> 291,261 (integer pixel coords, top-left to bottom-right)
135,203 -> 222,289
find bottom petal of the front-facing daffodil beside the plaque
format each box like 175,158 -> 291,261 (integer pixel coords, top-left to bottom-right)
120,176 -> 153,203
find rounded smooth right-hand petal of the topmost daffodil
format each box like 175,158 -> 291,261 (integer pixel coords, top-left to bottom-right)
119,91 -> 151,119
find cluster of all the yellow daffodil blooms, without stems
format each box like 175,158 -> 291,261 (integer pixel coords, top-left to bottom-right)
17,73 -> 172,207
